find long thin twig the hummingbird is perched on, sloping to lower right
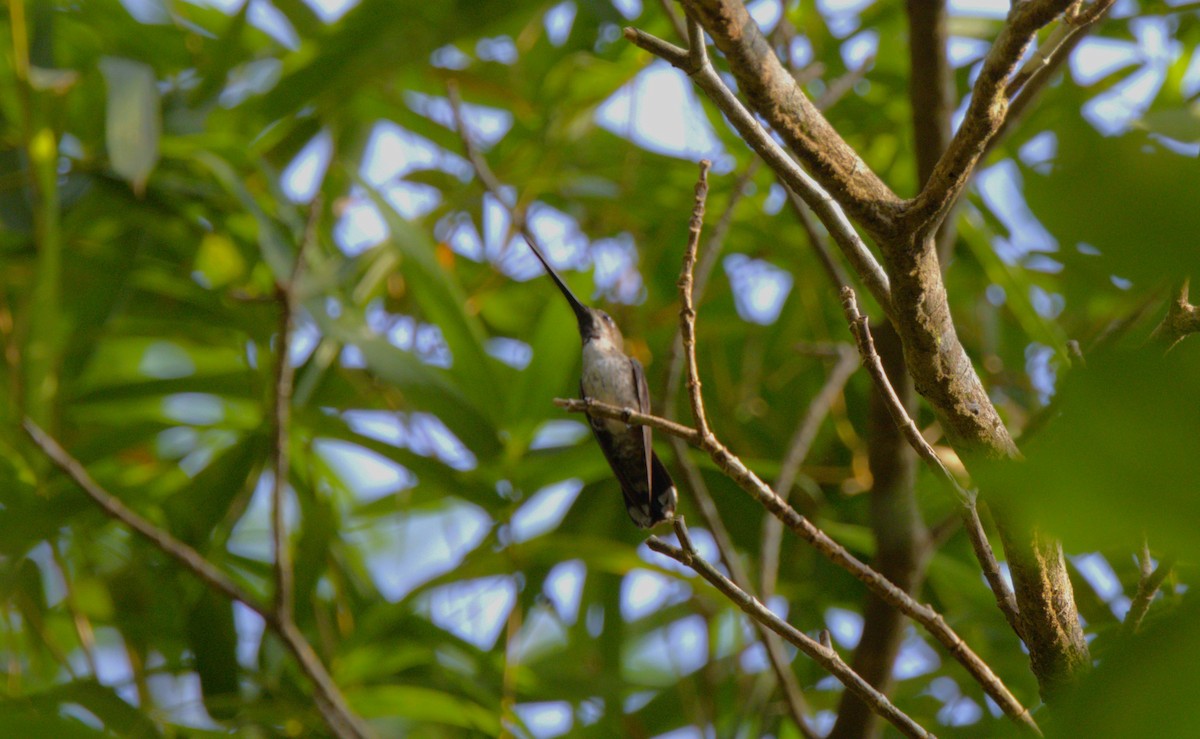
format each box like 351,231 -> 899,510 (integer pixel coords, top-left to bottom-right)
554,398 -> 1037,731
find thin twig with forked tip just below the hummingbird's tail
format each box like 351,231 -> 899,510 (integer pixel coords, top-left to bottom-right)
647,516 -> 932,737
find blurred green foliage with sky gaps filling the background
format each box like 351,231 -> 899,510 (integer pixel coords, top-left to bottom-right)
0,0 -> 1200,737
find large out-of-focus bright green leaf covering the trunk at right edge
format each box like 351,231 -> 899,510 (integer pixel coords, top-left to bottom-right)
983,341 -> 1200,553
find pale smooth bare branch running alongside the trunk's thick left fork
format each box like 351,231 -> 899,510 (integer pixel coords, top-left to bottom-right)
625,29 -> 892,314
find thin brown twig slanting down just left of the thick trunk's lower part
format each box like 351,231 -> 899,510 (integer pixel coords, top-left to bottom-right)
841,287 -> 1021,636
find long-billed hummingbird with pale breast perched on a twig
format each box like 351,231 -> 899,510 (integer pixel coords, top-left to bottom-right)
524,236 -> 678,529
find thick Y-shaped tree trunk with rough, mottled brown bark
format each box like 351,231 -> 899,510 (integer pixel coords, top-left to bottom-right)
683,0 -> 1090,696
